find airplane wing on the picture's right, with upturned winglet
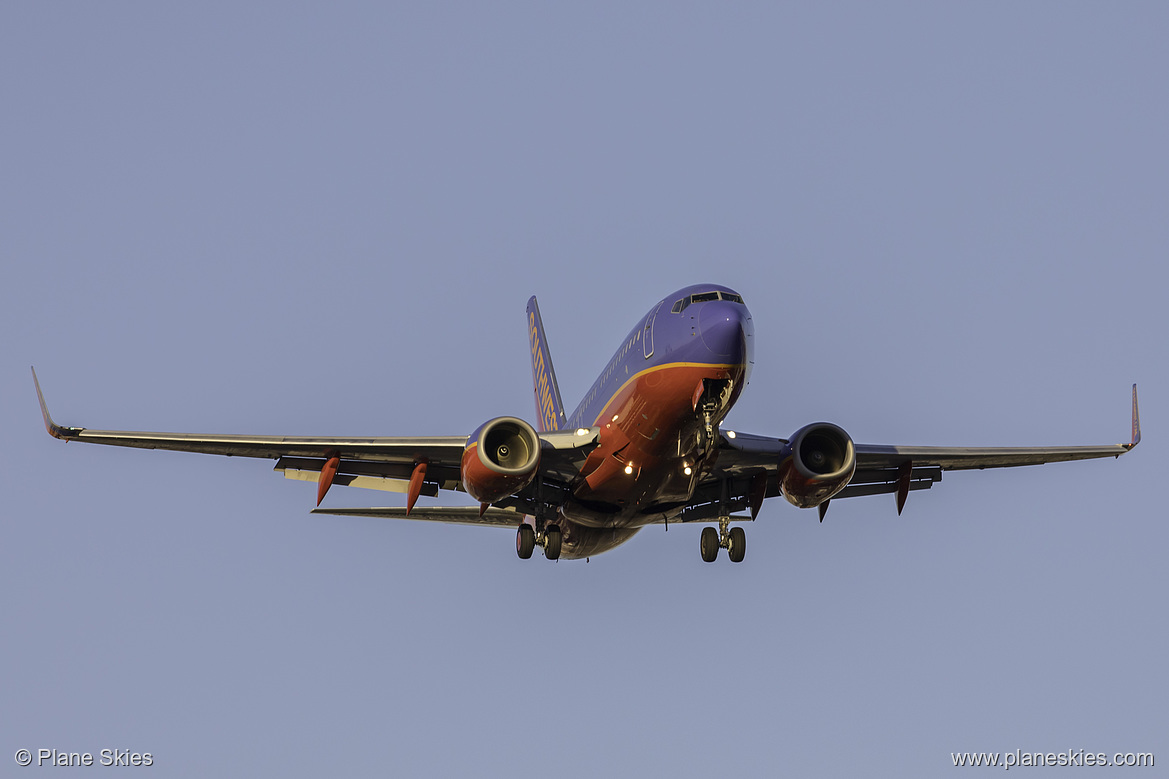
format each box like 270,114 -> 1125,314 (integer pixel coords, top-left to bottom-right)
683,385 -> 1141,509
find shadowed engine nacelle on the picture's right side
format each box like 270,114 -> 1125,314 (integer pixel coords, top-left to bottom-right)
779,422 -> 857,509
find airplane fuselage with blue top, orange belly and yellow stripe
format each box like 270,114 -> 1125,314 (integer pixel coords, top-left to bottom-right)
559,284 -> 754,558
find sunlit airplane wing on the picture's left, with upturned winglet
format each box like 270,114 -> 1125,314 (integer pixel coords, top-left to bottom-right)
33,370 -> 599,495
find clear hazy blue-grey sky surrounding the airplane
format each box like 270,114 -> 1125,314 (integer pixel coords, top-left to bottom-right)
0,2 -> 1169,777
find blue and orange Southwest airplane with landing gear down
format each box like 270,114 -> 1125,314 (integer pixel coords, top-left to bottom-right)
33,284 -> 1141,563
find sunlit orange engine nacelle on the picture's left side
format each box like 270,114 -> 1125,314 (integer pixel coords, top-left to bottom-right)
462,416 -> 540,503
